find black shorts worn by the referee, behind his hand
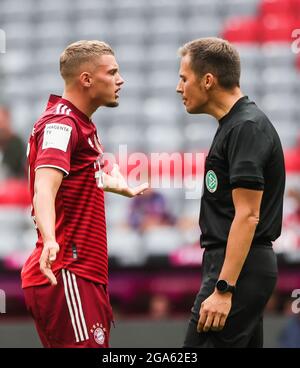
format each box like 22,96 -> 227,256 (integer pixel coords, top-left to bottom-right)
183,246 -> 277,348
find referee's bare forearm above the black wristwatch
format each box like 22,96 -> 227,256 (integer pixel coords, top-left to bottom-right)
219,216 -> 258,285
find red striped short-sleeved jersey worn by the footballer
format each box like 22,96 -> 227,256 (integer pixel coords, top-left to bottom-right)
21,95 -> 108,288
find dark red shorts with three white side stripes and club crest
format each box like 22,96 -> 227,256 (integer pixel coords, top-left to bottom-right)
24,269 -> 113,348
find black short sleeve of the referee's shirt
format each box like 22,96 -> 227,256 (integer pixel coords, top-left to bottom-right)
226,121 -> 272,190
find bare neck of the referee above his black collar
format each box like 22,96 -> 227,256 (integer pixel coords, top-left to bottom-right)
206,88 -> 244,120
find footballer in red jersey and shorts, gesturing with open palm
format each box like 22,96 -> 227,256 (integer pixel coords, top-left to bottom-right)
21,41 -> 148,347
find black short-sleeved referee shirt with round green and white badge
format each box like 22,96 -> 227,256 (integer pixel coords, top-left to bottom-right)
199,96 -> 285,248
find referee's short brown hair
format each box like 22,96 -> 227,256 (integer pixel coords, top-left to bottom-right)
179,37 -> 241,89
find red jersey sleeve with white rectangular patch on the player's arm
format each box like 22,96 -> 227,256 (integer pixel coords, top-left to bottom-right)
34,117 -> 78,175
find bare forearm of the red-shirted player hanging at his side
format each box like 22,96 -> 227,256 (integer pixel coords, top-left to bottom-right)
33,188 -> 56,243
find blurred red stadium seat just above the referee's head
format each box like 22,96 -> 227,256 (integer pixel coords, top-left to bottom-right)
223,17 -> 258,43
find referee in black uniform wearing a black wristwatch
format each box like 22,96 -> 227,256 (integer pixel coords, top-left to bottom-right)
177,38 -> 285,348
